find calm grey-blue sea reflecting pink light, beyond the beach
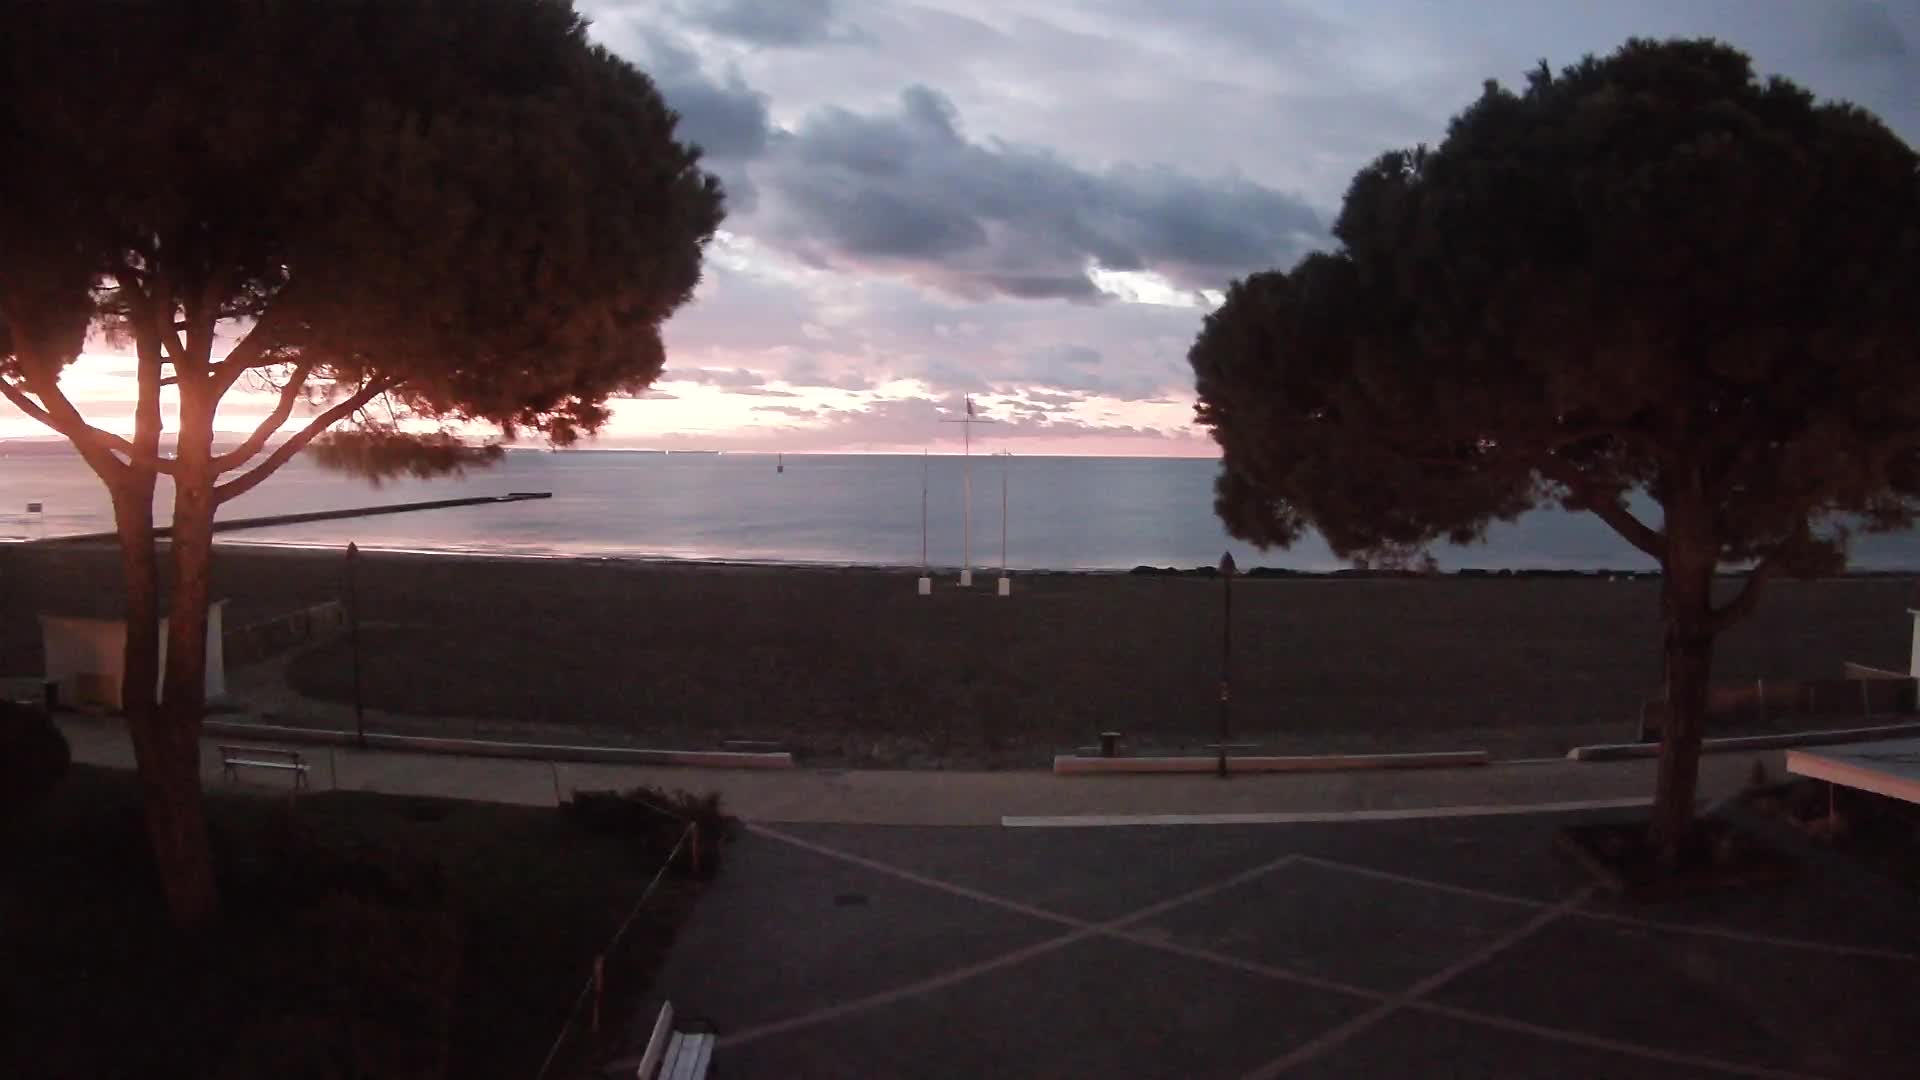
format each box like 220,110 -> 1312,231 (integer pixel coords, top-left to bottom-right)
0,441 -> 1920,571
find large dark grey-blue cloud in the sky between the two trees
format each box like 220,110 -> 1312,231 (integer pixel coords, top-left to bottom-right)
756,86 -> 1321,300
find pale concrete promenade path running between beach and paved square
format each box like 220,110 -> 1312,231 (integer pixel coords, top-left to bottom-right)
61,717 -> 1782,824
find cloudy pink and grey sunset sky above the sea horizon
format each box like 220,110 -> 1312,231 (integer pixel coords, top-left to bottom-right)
0,0 -> 1920,455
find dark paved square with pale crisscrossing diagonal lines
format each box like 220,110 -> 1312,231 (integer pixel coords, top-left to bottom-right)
648,817 -> 1920,1080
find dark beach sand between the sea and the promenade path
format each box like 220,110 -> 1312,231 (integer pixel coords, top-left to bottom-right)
0,546 -> 1912,767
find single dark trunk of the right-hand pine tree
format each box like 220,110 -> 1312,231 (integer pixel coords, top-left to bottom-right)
1651,509 -> 1718,863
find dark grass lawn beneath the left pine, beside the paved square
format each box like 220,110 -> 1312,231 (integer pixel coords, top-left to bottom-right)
0,767 -> 697,1078
